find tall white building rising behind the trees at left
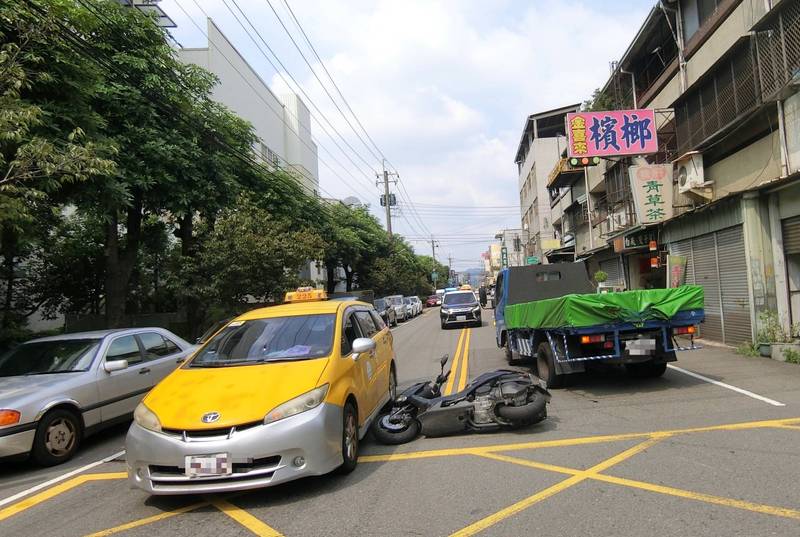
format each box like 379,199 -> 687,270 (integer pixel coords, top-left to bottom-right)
178,19 -> 319,195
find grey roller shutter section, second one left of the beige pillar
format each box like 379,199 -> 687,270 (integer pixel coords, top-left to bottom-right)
687,233 -> 723,341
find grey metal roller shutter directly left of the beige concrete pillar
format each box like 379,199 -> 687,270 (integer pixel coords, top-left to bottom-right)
717,226 -> 753,345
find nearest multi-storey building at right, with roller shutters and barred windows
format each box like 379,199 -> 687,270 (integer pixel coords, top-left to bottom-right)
550,0 -> 800,345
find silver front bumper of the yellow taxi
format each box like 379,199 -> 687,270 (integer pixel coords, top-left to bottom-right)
125,403 -> 343,494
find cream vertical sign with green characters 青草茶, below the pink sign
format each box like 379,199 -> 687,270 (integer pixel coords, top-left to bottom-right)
628,164 -> 674,224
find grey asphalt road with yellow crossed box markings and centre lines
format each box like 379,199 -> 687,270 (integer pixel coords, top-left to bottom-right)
0,310 -> 800,537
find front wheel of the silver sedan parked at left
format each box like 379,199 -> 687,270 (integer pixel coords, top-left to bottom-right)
31,409 -> 81,466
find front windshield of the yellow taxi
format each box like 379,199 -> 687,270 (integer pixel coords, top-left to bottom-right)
189,314 -> 336,367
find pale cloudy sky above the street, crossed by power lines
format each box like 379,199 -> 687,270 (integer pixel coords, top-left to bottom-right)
161,0 -> 654,269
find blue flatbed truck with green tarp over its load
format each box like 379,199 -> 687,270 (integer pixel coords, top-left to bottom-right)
495,262 -> 705,387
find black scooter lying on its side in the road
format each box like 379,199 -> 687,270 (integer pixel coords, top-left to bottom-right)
372,355 -> 550,444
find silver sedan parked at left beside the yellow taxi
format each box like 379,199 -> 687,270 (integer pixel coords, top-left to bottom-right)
0,328 -> 196,466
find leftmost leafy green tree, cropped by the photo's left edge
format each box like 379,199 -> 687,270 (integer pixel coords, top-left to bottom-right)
0,2 -> 114,329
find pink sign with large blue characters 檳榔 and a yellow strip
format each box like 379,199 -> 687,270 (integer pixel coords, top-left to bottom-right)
567,108 -> 658,157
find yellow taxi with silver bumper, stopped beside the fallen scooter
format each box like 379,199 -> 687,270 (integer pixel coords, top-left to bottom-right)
126,288 -> 397,494
